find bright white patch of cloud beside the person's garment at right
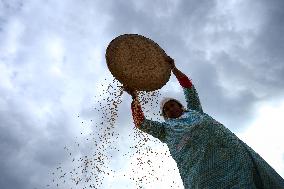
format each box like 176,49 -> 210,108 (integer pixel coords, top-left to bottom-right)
238,100 -> 284,177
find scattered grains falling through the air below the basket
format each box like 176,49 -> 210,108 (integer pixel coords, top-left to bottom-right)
46,79 -> 179,189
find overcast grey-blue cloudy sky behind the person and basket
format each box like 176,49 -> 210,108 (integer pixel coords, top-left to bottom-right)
0,0 -> 284,189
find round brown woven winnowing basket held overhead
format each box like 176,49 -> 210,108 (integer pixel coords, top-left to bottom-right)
106,34 -> 171,91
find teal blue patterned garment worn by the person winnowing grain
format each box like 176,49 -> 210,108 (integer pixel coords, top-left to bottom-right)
139,86 -> 284,189
